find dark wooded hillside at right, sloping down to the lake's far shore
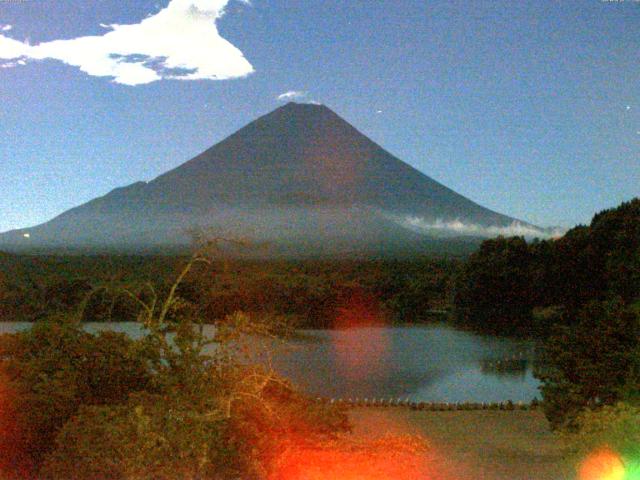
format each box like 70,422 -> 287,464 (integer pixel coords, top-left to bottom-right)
454,199 -> 640,336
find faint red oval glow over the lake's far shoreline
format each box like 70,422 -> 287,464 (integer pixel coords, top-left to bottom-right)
330,292 -> 389,379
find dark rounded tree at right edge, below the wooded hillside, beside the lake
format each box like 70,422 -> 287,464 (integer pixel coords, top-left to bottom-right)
535,299 -> 640,428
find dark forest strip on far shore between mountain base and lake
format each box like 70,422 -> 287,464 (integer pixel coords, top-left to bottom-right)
0,254 -> 459,328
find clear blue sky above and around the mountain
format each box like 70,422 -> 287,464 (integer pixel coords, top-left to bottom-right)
0,0 -> 640,231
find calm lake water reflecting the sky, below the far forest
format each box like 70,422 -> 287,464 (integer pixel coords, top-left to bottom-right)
0,323 -> 539,402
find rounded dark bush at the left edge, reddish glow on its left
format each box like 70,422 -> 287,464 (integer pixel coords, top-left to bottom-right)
0,320 -> 151,471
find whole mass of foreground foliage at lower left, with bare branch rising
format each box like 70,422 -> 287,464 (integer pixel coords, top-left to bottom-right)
0,253 -> 349,479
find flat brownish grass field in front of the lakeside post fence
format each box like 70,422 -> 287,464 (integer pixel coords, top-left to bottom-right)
350,408 -> 574,480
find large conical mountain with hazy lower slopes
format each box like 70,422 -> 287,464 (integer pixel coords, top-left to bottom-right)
0,103 -> 538,254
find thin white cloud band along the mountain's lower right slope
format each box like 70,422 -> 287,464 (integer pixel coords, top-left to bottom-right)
390,216 -> 564,238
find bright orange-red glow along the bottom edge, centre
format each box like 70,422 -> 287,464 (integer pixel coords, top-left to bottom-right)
269,437 -> 444,480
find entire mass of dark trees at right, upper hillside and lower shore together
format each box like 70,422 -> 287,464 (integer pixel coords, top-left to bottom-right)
454,199 -> 640,430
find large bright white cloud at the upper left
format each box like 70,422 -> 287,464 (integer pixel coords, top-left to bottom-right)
0,0 -> 253,85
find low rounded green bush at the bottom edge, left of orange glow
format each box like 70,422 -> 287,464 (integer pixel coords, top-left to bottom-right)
39,395 -> 240,480
